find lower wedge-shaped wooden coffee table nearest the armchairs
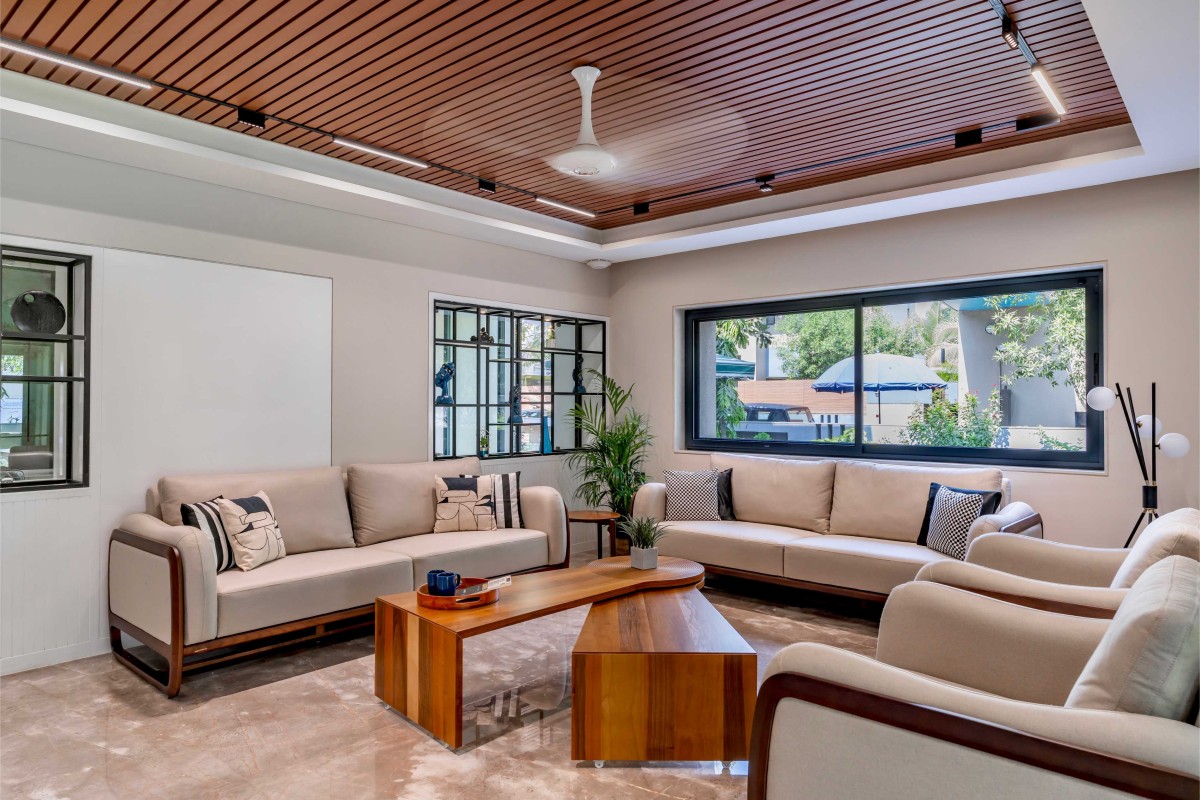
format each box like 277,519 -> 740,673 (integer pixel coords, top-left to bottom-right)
571,575 -> 758,765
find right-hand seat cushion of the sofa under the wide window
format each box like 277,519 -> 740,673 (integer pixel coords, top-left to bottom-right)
784,534 -> 955,595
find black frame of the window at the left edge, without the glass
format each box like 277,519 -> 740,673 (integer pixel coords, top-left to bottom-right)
0,242 -> 92,494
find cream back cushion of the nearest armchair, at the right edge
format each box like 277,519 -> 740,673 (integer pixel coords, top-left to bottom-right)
1067,555 -> 1200,721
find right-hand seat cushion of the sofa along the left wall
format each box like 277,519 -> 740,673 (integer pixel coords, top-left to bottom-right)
374,528 -> 550,584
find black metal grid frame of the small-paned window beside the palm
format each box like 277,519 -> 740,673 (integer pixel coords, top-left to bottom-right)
428,294 -> 608,461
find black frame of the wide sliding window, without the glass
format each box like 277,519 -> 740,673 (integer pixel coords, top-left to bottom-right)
684,266 -> 1105,471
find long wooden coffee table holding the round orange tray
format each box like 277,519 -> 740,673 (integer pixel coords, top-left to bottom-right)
376,557 -> 700,748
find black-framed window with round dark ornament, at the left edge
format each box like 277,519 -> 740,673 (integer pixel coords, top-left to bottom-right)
0,245 -> 91,492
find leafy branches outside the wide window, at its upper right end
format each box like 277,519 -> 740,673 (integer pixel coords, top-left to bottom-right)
984,289 -> 1087,408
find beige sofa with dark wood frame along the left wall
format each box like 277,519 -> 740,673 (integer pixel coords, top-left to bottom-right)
108,458 -> 569,696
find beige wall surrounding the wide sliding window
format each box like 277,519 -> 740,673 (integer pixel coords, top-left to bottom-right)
610,172 -> 1200,546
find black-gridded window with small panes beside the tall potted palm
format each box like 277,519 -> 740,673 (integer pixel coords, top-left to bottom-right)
433,300 -> 607,459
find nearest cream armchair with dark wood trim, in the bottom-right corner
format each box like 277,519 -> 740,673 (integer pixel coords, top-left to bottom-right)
749,559 -> 1200,800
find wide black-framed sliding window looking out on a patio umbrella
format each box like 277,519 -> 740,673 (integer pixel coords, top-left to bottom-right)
684,269 -> 1104,469
